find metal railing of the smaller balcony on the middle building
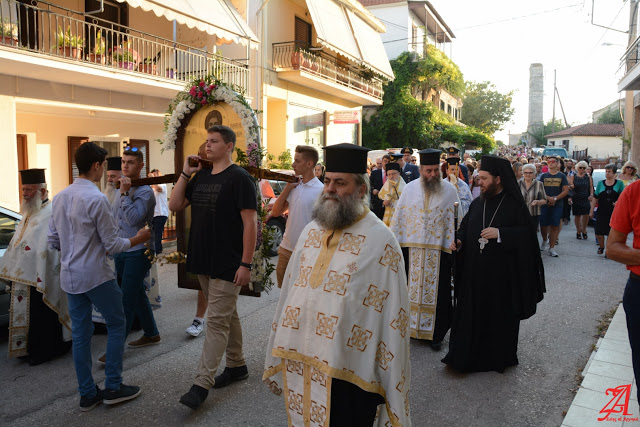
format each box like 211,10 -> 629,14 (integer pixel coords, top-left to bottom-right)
273,41 -> 383,99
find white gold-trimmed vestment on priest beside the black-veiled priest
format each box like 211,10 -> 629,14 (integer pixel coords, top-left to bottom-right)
390,179 -> 462,340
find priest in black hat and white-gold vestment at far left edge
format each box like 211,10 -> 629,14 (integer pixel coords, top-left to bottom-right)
0,169 -> 71,366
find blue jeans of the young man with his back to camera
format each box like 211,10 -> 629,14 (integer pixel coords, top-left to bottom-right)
67,280 -> 127,398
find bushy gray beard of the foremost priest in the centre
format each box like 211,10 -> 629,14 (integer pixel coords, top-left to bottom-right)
311,191 -> 364,230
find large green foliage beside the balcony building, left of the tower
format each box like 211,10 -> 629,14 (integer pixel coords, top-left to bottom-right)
362,51 -> 494,154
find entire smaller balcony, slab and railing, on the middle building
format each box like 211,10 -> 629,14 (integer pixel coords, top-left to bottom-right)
273,42 -> 383,105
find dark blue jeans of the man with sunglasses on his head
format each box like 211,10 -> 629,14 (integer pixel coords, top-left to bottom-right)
114,249 -> 159,337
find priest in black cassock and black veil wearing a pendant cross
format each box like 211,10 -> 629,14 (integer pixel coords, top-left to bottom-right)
442,156 -> 545,372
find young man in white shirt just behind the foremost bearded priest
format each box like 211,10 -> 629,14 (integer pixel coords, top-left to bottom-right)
271,145 -> 324,288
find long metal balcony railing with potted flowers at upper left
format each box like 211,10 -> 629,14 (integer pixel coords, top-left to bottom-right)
0,0 -> 249,94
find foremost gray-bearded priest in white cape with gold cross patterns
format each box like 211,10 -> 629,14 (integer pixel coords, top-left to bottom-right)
262,143 -> 411,426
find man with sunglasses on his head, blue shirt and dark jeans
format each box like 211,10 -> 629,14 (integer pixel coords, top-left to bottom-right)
113,147 -> 160,348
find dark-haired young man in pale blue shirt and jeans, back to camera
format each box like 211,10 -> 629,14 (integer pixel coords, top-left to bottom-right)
48,142 -> 151,411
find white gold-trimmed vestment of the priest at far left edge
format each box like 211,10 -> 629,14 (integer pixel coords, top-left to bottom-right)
0,202 -> 71,357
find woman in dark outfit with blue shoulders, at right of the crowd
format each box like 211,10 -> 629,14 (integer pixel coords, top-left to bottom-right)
589,163 -> 624,255
